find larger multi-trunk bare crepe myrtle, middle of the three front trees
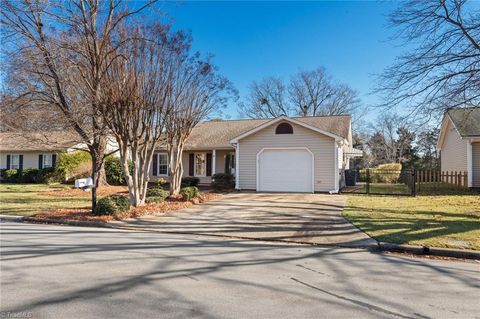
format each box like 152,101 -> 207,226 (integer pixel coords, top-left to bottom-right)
100,24 -> 181,207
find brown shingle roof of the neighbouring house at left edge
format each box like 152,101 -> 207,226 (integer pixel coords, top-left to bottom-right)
0,131 -> 81,152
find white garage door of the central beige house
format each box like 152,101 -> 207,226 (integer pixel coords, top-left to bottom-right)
257,149 -> 313,193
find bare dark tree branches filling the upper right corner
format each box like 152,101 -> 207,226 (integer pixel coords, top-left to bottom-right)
375,0 -> 480,118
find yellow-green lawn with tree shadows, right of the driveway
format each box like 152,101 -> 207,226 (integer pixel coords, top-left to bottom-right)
344,191 -> 480,250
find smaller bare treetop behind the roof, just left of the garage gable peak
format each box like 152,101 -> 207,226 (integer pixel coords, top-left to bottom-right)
240,77 -> 291,118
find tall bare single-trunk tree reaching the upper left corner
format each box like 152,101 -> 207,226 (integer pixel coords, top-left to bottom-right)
0,0 -> 153,209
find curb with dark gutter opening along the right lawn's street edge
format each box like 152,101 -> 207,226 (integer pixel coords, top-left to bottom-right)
378,242 -> 480,260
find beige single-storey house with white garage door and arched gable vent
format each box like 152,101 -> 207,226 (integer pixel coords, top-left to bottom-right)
150,115 -> 362,192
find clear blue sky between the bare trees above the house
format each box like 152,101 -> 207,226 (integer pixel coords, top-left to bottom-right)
162,1 -> 404,118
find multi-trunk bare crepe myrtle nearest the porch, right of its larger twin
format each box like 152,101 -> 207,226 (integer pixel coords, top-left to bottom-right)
165,53 -> 237,195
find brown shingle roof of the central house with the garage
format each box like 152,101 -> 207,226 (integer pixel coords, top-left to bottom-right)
185,115 -> 350,149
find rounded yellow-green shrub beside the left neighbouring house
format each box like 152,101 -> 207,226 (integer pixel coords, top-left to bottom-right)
55,151 -> 92,181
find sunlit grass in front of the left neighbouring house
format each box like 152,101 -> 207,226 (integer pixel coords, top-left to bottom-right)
0,184 -> 90,216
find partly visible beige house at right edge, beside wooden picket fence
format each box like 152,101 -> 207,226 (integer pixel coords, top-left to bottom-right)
437,107 -> 480,188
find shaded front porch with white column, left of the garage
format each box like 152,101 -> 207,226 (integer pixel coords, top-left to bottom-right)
150,148 -> 235,185
